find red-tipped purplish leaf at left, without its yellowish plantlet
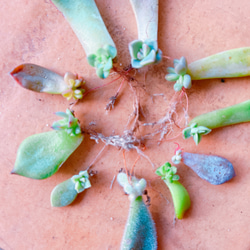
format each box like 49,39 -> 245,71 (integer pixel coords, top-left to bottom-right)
10,63 -> 68,94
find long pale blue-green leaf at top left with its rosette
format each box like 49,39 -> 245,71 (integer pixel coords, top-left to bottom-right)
52,0 -> 117,78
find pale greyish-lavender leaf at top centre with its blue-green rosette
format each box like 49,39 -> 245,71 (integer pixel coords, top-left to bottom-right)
129,0 -> 162,69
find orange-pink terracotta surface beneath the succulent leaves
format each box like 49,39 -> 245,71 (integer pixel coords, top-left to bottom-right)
0,0 -> 250,250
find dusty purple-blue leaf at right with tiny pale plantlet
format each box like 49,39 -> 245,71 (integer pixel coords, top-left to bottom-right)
172,149 -> 235,185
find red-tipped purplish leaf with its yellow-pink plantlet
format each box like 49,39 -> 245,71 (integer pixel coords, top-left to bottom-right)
10,63 -> 85,100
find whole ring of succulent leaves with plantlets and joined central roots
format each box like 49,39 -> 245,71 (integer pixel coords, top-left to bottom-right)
10,0 -> 250,249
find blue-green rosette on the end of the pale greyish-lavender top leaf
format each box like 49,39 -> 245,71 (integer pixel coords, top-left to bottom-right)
129,40 -> 162,69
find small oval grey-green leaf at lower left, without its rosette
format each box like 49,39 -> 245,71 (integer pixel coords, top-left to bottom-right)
50,179 -> 78,207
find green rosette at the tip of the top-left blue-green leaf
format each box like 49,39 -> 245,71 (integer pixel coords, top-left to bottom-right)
87,45 -> 117,79
